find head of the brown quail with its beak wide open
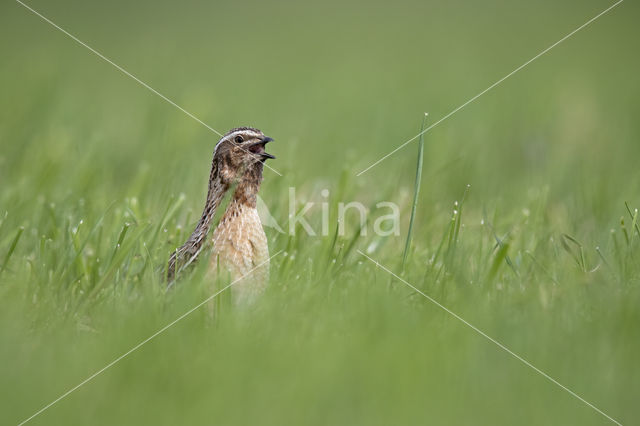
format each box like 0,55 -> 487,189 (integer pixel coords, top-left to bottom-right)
214,127 -> 276,181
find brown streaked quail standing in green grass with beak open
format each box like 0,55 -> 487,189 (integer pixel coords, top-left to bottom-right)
167,127 -> 276,305
